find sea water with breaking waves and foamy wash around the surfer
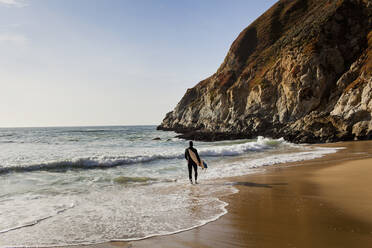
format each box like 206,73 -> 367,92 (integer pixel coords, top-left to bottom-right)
0,126 -> 336,247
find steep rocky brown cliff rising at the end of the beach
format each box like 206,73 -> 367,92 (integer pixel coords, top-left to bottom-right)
158,0 -> 372,143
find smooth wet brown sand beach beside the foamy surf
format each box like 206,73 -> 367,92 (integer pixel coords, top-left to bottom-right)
66,141 -> 372,248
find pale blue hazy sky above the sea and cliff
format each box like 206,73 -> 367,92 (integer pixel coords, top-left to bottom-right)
0,0 -> 276,127
